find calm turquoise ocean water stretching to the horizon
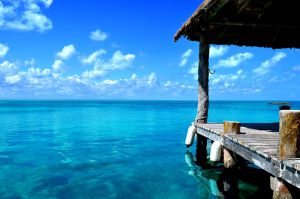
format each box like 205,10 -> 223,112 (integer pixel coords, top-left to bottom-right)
0,101 -> 300,199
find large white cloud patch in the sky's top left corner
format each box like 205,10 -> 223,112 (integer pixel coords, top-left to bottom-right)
0,0 -> 52,32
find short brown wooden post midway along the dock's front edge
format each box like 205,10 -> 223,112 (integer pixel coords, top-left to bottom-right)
223,121 -> 241,169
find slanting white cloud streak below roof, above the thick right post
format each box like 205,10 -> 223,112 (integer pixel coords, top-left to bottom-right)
253,52 -> 286,76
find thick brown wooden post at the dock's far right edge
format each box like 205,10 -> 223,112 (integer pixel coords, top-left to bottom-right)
271,110 -> 300,199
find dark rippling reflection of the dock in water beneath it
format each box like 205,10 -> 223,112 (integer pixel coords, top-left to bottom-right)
185,151 -> 272,198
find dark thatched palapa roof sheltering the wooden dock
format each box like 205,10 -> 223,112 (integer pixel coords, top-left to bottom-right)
174,0 -> 300,48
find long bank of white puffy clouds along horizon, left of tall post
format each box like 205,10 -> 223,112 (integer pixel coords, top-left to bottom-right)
0,44 -> 195,99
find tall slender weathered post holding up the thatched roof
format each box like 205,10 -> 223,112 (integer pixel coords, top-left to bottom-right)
196,34 -> 209,165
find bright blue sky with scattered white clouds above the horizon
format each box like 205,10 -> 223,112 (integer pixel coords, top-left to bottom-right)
0,0 -> 300,100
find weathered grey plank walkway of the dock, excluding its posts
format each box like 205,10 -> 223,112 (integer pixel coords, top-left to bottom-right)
195,123 -> 300,188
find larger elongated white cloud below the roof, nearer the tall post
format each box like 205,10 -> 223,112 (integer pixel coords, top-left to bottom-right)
213,52 -> 253,68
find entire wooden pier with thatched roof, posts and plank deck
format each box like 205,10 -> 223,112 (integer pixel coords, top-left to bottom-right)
174,0 -> 300,198
